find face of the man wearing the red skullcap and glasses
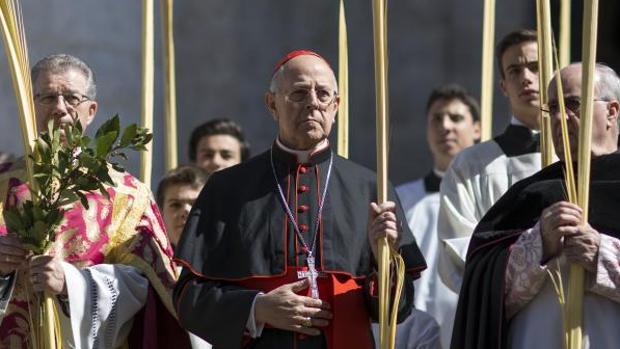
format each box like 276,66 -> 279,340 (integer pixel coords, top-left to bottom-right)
266,56 -> 339,150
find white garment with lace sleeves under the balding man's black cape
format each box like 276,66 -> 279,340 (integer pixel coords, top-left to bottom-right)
504,225 -> 620,349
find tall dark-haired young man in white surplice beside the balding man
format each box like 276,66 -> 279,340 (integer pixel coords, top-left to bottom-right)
437,30 -> 541,292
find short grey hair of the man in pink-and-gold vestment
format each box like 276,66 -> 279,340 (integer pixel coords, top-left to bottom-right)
30,53 -> 97,100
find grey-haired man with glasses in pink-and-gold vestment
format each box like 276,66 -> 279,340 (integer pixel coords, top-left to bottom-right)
0,54 -> 189,348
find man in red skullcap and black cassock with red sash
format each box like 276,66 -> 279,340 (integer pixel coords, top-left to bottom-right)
175,50 -> 425,348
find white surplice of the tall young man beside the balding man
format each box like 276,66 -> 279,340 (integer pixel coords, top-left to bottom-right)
437,118 -> 541,292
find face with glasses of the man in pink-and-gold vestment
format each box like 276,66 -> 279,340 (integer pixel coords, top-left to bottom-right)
33,69 -> 97,132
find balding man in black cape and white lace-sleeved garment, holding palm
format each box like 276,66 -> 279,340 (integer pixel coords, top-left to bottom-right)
451,63 -> 620,349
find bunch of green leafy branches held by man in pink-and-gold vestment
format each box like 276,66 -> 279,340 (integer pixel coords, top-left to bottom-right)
3,115 -> 153,254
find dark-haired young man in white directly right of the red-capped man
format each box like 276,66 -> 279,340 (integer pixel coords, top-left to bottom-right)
396,84 -> 480,348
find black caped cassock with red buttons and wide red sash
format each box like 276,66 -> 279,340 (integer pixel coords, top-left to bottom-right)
174,144 -> 426,349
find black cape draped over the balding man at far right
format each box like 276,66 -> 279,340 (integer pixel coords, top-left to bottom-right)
451,153 -> 620,349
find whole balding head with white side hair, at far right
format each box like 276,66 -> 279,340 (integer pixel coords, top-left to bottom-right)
549,63 -> 620,159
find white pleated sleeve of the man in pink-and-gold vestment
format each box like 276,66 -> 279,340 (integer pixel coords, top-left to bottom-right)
62,262 -> 149,349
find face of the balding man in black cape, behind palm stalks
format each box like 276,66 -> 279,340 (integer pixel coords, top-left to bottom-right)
549,64 -> 618,161
